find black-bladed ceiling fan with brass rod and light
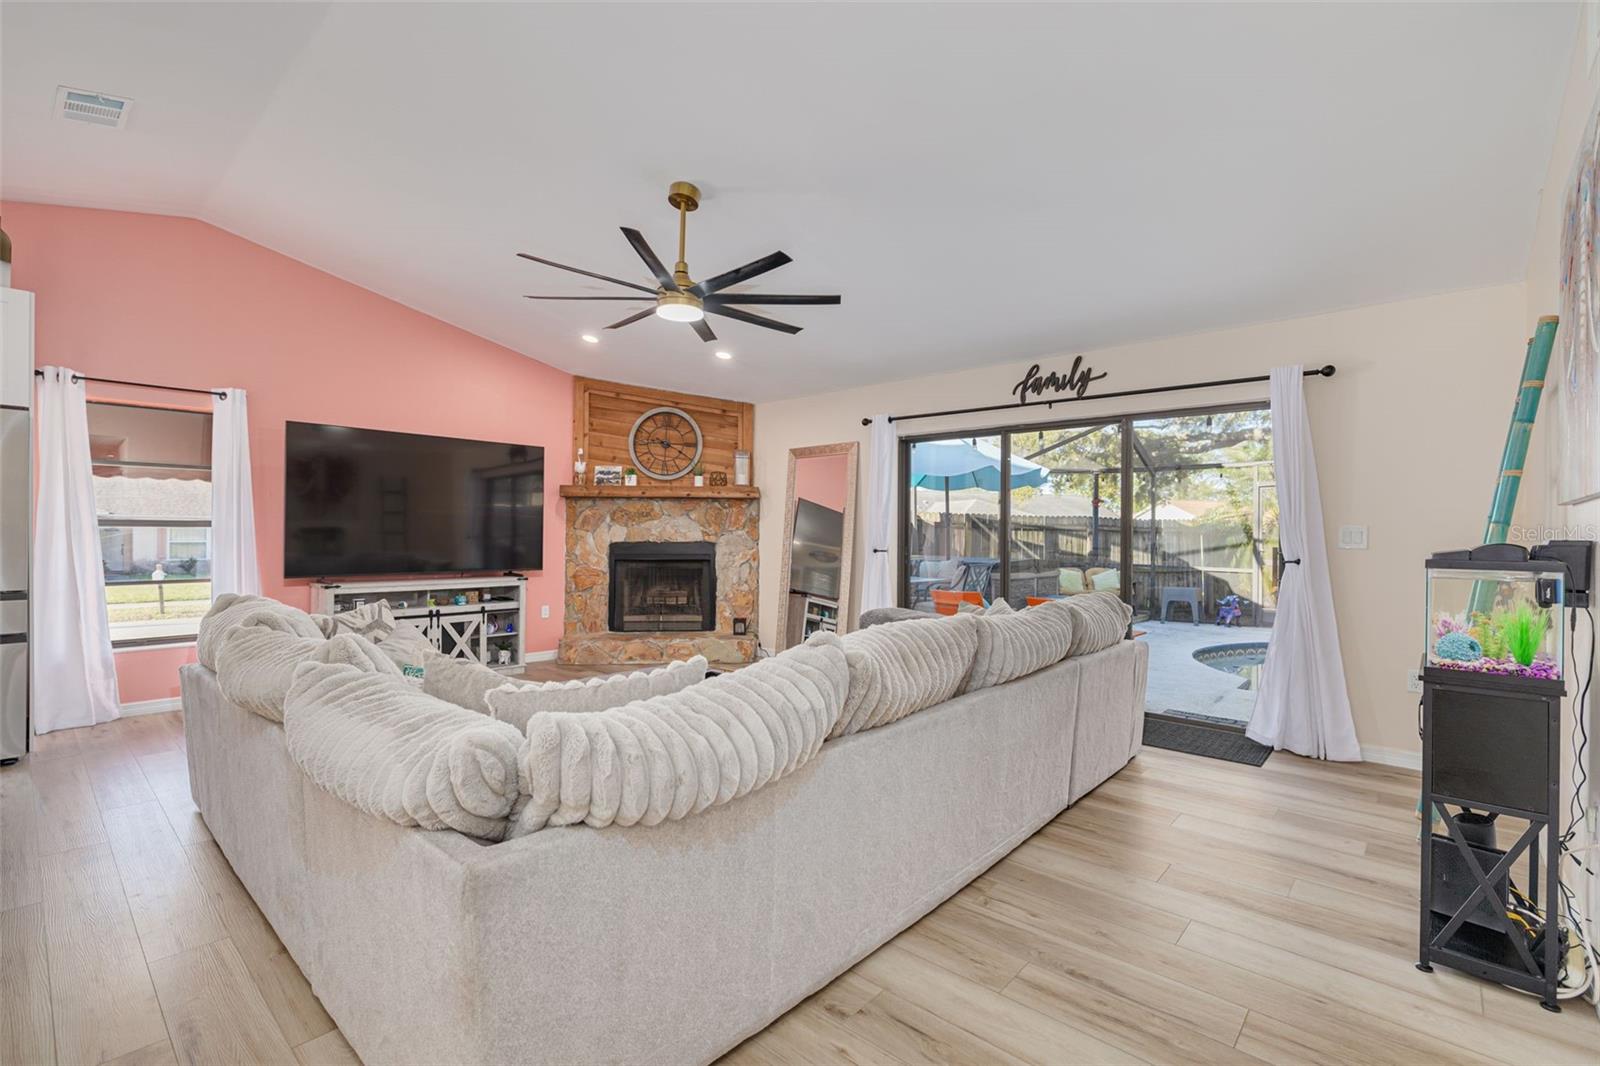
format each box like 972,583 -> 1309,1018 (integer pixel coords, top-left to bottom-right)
517,181 -> 840,341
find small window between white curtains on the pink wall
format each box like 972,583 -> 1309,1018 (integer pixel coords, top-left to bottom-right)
88,402 -> 211,648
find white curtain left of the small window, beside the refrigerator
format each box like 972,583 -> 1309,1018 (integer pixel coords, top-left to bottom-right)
30,367 -> 120,733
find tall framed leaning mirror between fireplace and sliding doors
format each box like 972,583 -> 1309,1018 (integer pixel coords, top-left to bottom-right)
778,442 -> 856,650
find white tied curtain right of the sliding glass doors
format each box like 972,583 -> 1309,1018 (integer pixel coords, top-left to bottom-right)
1246,367 -> 1362,762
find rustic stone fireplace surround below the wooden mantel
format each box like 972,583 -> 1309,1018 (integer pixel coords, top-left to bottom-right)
557,487 -> 760,664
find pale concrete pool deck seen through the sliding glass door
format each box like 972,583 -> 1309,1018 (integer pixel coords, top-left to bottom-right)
1133,619 -> 1272,725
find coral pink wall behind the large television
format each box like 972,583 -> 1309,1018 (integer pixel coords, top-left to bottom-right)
0,202 -> 573,703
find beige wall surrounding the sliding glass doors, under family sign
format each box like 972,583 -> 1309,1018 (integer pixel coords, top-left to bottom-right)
755,283 -> 1544,757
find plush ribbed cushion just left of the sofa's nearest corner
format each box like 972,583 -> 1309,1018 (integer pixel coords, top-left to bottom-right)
283,663 -> 522,840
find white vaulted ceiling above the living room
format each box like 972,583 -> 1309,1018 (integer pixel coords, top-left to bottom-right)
0,3 -> 1578,400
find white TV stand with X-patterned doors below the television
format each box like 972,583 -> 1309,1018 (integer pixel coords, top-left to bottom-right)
310,575 -> 528,671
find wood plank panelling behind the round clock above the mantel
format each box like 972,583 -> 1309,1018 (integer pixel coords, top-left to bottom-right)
573,378 -> 755,485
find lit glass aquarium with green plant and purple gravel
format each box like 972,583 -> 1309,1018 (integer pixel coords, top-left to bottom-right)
1427,567 -> 1566,680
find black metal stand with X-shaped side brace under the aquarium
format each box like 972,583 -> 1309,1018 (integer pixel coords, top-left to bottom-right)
1418,666 -> 1565,1010
